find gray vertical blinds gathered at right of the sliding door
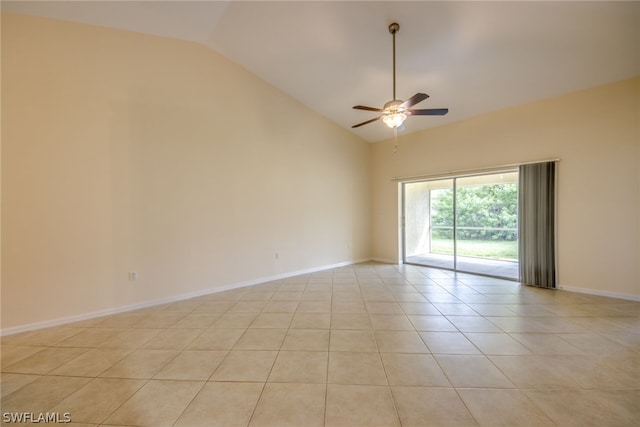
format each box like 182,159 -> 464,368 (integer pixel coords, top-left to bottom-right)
518,162 -> 556,288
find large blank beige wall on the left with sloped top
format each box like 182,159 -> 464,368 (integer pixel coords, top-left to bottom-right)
2,14 -> 371,329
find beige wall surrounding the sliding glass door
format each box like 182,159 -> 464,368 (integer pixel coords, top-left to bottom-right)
372,78 -> 640,298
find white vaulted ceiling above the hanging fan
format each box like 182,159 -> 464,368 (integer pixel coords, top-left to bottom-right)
2,0 -> 640,142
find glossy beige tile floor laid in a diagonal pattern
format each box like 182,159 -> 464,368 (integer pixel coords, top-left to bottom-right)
1,263 -> 640,427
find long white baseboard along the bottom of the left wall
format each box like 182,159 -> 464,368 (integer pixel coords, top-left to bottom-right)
0,258 -> 372,337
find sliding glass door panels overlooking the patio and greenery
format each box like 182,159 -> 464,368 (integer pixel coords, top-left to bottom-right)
403,170 -> 519,280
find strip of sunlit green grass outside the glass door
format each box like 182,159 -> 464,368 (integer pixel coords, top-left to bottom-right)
431,239 -> 518,261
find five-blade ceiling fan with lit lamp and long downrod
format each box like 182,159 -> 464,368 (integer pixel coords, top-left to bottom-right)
351,22 -> 449,129
